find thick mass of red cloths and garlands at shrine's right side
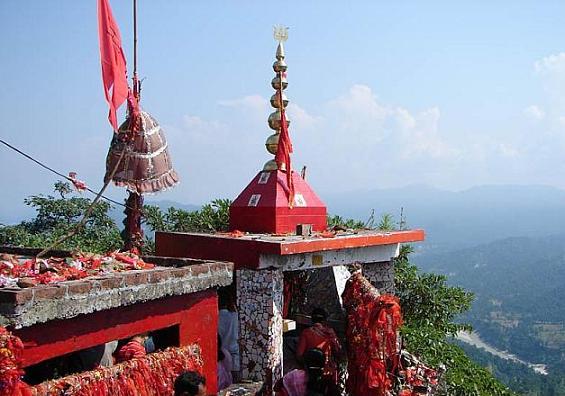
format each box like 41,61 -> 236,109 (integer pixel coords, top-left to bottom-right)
343,272 -> 438,396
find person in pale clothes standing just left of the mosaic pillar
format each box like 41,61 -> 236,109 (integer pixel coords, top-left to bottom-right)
218,289 -> 240,382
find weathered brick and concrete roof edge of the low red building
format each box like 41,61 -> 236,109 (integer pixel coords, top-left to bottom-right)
0,261 -> 233,329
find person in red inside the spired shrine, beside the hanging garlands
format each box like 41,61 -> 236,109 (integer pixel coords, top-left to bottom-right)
296,308 -> 343,390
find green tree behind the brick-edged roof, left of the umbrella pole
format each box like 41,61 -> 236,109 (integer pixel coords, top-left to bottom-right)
0,182 -> 123,253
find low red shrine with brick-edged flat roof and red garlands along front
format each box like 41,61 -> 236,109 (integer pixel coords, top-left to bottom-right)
0,247 -> 233,396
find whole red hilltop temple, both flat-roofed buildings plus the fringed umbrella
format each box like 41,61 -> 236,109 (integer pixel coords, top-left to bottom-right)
0,23 -> 432,395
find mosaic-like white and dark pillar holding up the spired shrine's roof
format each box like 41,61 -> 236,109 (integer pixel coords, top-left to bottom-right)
236,269 -> 283,387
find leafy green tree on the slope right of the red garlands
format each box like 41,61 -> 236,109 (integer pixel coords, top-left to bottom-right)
395,246 -> 513,396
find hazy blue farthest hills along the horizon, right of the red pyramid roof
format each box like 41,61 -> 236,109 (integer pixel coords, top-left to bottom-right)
321,185 -> 565,252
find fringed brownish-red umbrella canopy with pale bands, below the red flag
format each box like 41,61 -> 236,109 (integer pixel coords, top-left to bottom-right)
104,111 -> 179,195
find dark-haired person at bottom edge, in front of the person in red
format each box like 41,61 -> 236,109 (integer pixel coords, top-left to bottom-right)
274,348 -> 339,396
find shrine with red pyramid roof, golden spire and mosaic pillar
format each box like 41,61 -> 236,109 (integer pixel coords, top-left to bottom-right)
155,28 -> 424,387
